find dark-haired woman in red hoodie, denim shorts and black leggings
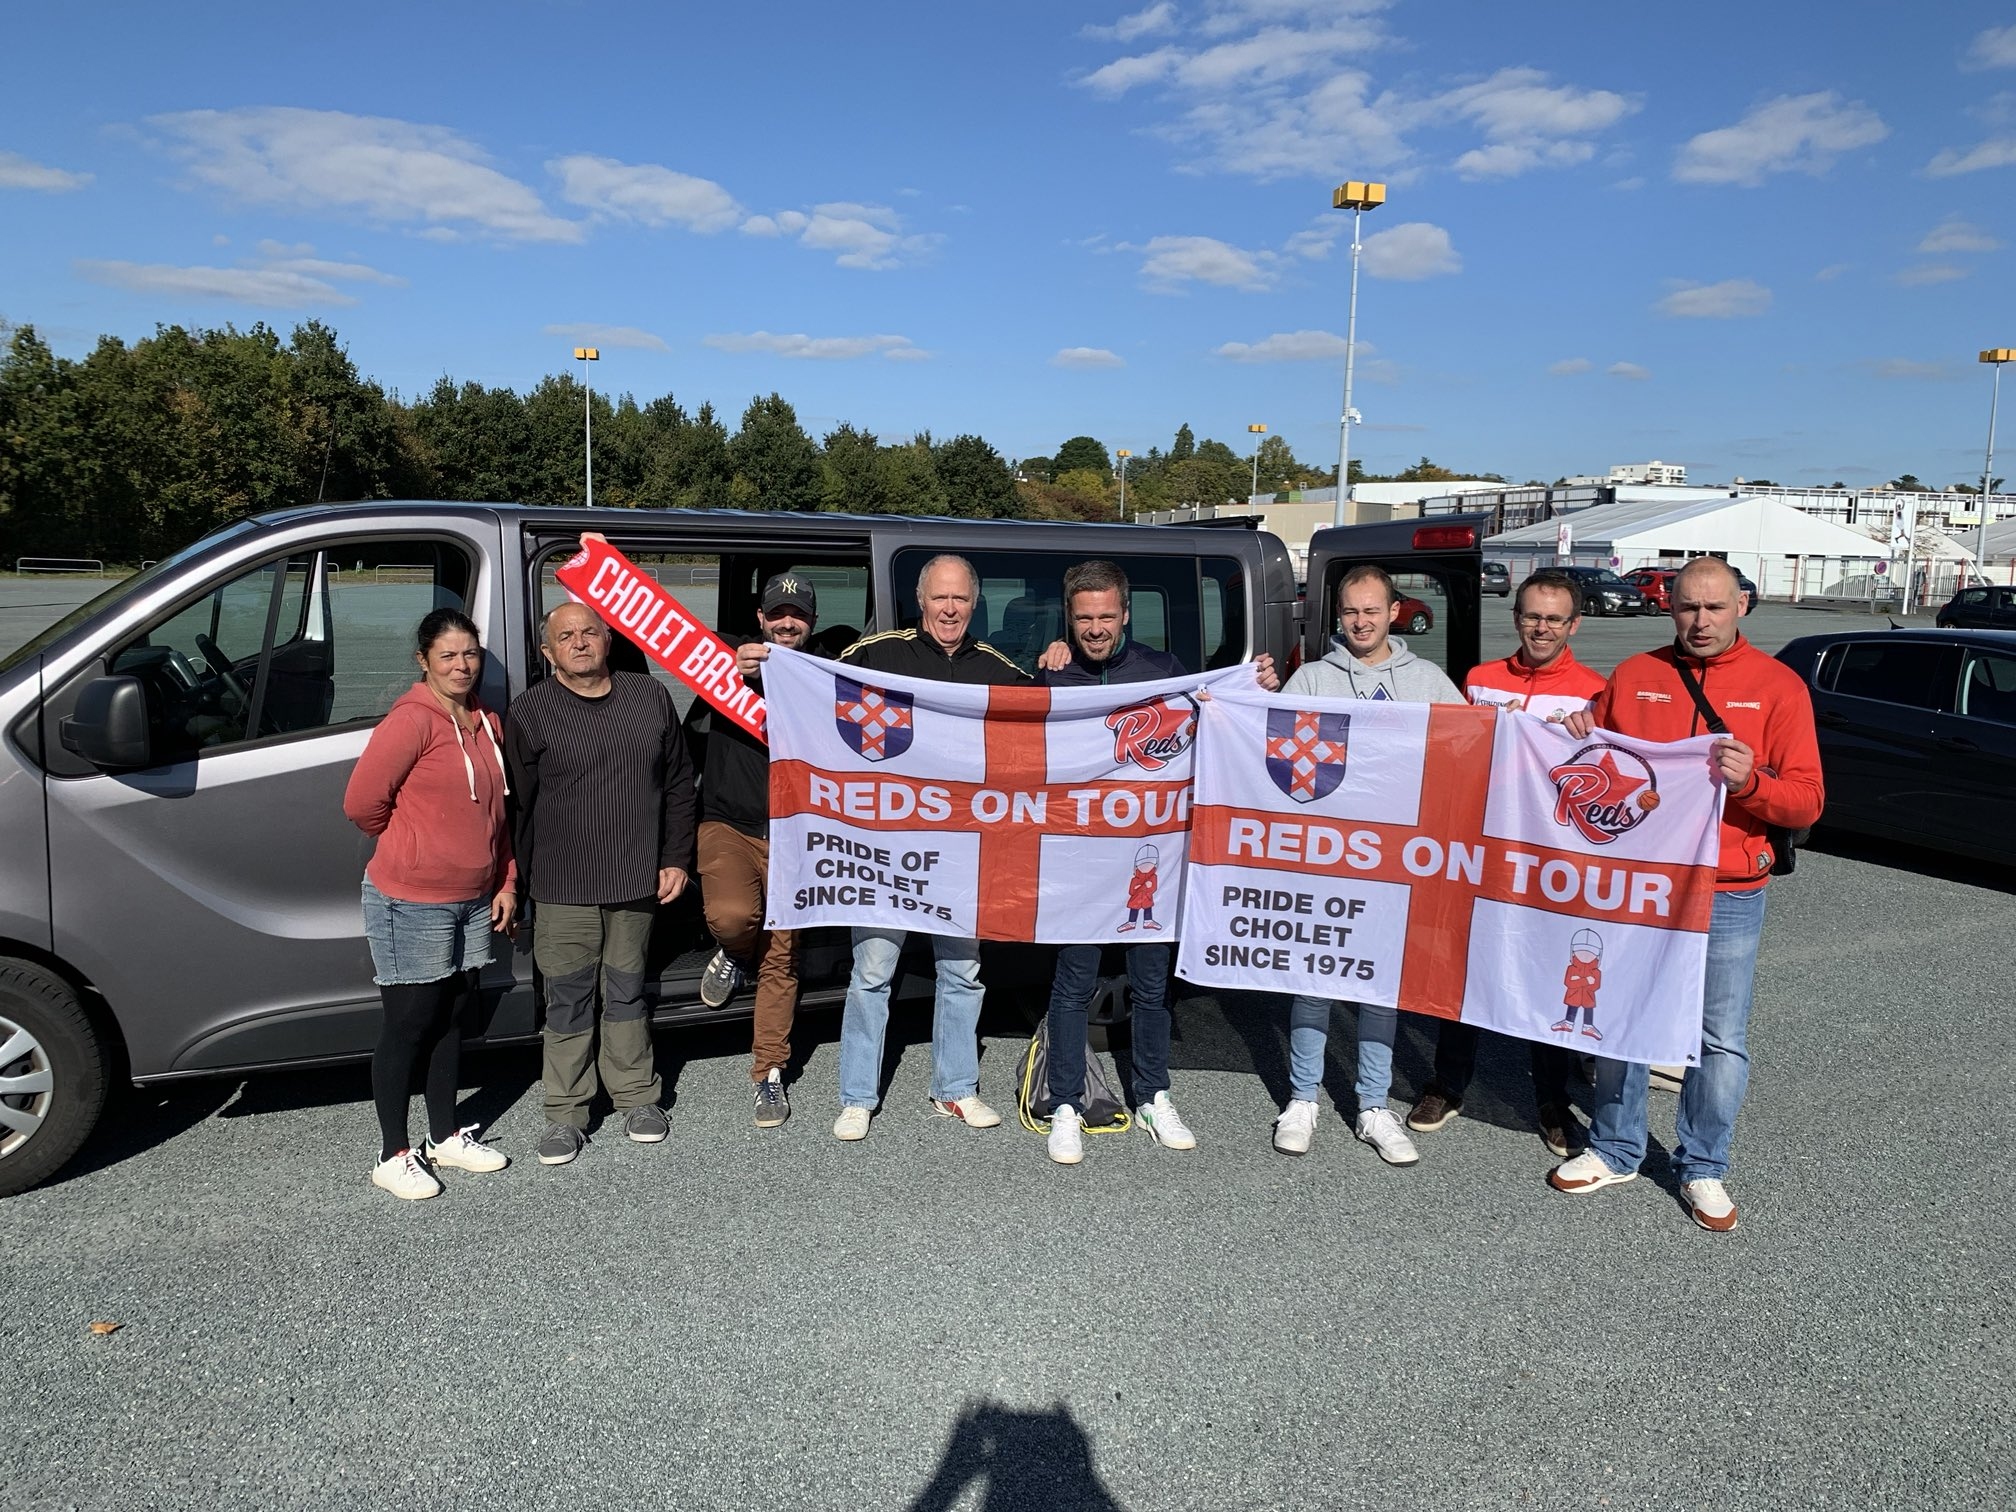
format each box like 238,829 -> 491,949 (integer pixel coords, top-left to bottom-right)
343,609 -> 518,1198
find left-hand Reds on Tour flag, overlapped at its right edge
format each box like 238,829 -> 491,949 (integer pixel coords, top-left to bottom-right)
764,649 -> 1254,943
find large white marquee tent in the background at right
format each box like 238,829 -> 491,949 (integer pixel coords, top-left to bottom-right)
1484,490 -> 1903,599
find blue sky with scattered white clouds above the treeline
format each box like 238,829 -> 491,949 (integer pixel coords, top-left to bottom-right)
0,0 -> 2016,484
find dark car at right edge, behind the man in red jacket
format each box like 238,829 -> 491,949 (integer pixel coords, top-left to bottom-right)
1778,629 -> 2016,865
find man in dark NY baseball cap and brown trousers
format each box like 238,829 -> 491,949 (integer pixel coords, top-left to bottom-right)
698,573 -> 818,1129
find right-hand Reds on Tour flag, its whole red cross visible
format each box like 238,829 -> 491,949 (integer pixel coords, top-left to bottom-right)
1177,683 -> 1724,1064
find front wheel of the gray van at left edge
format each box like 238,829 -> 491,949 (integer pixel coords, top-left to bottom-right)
0,960 -> 105,1198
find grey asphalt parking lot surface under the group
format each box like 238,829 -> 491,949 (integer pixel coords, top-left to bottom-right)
0,572 -> 2016,1512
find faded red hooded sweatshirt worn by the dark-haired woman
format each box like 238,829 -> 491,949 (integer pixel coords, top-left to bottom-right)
343,683 -> 518,903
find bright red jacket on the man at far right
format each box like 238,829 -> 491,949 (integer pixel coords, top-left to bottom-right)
1595,635 -> 1826,891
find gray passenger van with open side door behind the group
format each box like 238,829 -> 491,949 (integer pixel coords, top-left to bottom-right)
0,502 -> 1338,1195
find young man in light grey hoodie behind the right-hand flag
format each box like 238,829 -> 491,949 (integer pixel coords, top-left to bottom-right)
1274,562 -> 1464,1165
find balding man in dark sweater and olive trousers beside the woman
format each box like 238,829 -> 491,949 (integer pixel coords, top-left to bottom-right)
504,603 -> 694,1165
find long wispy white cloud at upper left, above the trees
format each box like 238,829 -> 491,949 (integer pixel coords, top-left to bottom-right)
149,107 -> 583,242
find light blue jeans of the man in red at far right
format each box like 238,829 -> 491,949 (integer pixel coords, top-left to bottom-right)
1589,887 -> 1764,1181
